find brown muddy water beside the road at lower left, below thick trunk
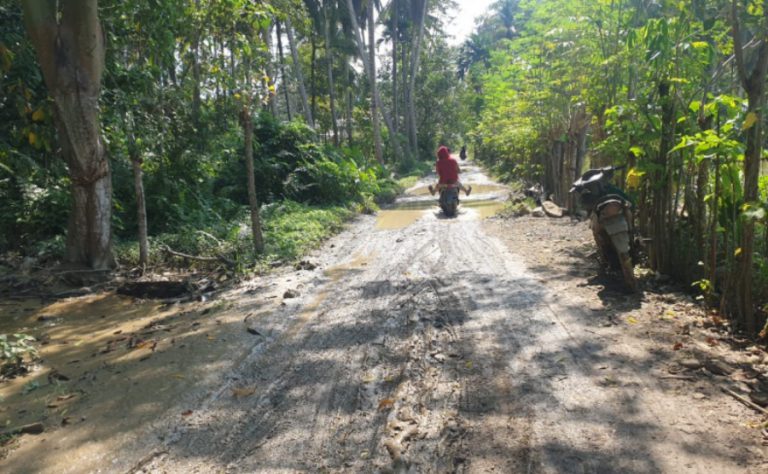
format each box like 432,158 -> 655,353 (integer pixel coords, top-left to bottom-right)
0,293 -> 252,473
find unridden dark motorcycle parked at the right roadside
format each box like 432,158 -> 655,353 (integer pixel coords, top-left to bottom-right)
570,166 -> 637,292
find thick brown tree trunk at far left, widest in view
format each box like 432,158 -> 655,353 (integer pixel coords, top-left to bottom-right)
22,0 -> 115,270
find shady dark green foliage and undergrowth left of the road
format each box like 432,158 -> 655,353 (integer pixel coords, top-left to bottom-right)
0,0 -> 458,272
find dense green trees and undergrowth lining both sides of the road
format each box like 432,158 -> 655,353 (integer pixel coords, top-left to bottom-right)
0,0 -> 768,333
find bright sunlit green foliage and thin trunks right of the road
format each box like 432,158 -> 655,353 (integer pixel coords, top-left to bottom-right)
459,0 -> 768,333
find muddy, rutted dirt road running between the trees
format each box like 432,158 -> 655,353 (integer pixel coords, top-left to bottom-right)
126,165 -> 766,473
